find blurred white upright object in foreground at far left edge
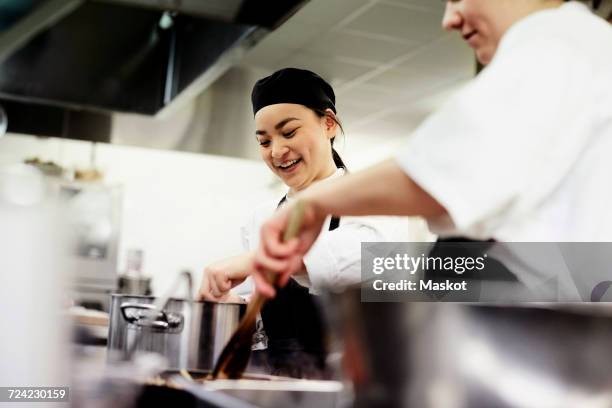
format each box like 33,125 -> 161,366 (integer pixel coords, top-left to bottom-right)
0,164 -> 70,394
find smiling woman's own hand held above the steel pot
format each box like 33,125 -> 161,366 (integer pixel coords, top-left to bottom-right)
198,252 -> 253,302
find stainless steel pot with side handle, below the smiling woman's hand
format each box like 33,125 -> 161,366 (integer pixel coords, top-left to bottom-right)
108,294 -> 246,370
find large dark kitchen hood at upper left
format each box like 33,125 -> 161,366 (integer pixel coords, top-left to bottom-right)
0,0 -> 305,118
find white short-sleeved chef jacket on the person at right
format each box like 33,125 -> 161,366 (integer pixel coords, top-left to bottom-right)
396,2 -> 612,242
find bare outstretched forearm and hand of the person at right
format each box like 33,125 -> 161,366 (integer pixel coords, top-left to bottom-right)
253,159 -> 446,297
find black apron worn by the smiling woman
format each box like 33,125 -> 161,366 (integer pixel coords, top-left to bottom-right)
255,197 -> 340,379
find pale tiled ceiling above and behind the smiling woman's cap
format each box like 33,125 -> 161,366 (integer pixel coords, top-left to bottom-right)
238,0 -> 475,163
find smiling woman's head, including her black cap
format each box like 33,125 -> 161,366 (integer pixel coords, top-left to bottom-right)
251,68 -> 346,194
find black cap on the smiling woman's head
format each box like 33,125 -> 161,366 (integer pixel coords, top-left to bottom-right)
251,68 -> 336,115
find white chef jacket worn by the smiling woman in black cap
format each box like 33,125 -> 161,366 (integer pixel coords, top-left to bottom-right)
236,169 -> 432,294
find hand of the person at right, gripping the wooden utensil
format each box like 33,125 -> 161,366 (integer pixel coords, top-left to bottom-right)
252,200 -> 326,297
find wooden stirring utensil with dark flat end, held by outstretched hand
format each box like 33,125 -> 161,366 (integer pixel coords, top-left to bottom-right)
212,201 -> 305,379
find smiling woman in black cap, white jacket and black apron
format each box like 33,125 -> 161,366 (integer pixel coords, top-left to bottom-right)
200,68 -> 418,377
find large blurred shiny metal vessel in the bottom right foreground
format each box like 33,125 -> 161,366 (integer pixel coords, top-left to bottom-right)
325,288 -> 612,408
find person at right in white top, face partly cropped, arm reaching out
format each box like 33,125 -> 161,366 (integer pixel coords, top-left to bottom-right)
253,0 -> 612,297
